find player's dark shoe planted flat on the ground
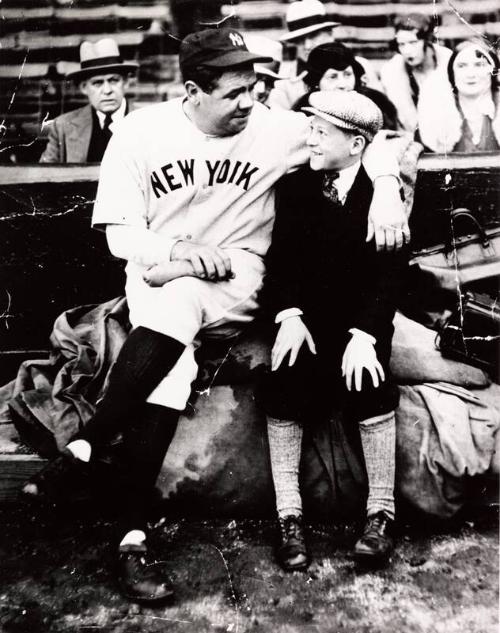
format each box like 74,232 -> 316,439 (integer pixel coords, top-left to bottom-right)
117,545 -> 174,605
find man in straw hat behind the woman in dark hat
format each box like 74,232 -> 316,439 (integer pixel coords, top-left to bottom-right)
269,0 -> 380,110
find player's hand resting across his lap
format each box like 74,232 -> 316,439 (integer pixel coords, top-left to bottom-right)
170,241 -> 233,281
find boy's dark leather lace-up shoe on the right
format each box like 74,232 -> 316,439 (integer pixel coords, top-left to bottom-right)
353,510 -> 394,564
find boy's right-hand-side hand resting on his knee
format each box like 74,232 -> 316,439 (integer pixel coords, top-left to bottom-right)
342,334 -> 385,391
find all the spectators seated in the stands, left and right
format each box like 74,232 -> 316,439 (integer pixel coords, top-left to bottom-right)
4,0 -> 500,162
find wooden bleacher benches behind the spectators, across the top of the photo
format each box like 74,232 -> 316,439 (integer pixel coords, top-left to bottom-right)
0,0 -> 500,163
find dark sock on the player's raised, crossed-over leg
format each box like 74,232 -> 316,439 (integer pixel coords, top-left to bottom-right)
79,327 -> 185,448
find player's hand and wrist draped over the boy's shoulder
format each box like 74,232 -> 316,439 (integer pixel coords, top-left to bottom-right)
366,176 -> 410,251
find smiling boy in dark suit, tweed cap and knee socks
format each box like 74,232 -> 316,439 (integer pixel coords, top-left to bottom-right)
263,91 -> 406,571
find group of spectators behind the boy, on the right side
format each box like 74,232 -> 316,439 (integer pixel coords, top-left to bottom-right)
258,0 -> 500,153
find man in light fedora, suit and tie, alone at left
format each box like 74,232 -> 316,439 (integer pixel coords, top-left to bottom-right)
40,38 -> 138,163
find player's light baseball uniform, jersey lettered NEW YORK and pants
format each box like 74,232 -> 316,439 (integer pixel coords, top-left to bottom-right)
92,99 -> 308,410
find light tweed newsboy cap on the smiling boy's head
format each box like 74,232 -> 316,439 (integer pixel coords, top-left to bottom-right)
302,90 -> 383,141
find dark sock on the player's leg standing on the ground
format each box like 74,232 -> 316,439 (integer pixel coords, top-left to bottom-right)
118,404 -> 180,538
